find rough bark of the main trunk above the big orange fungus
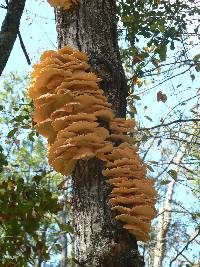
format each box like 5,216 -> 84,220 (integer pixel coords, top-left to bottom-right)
56,0 -> 128,117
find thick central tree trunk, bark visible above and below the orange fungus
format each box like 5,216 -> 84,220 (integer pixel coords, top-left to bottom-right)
56,0 -> 144,267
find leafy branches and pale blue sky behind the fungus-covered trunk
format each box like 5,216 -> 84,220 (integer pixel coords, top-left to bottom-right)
0,0 -> 200,266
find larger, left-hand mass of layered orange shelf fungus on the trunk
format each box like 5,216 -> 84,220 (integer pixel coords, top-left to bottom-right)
28,46 -> 114,175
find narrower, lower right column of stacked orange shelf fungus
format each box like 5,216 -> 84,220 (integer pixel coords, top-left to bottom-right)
103,144 -> 156,242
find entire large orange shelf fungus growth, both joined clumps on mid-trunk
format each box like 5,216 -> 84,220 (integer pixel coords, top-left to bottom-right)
28,46 -> 155,241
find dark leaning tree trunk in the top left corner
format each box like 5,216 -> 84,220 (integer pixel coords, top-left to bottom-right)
0,0 -> 26,75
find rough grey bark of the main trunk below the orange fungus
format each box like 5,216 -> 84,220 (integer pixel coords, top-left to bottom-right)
73,159 -> 143,267
